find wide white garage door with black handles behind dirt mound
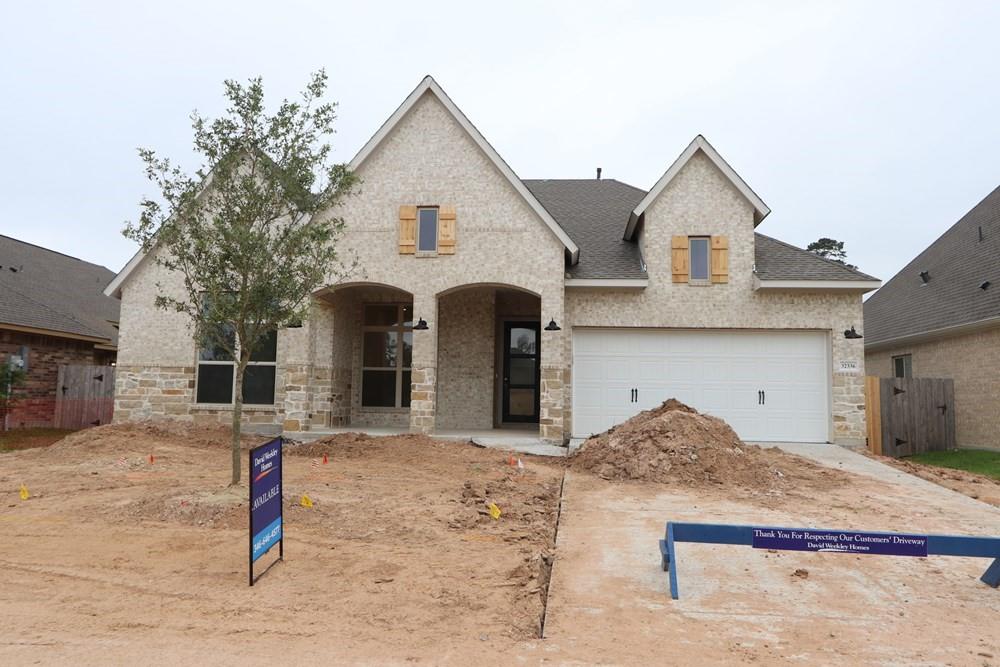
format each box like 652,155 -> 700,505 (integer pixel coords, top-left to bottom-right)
573,329 -> 830,442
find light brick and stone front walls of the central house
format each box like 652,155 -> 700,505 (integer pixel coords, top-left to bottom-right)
117,87 -> 864,442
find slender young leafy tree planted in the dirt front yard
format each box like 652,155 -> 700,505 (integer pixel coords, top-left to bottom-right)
123,70 -> 355,485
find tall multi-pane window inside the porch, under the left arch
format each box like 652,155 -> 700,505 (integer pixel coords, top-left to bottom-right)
361,303 -> 413,408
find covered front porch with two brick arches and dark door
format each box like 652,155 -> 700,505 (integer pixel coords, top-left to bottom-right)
308,283 -> 562,444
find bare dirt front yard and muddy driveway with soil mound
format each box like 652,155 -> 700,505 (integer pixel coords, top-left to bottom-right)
0,410 -> 1000,667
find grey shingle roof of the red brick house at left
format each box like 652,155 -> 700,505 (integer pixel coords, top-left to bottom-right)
0,235 -> 120,345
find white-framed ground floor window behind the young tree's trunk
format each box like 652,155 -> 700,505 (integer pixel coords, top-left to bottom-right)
195,331 -> 278,405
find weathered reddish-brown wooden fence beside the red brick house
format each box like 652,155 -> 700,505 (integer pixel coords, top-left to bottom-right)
54,366 -> 115,428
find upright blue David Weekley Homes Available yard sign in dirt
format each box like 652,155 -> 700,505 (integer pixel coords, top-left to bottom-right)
249,437 -> 285,586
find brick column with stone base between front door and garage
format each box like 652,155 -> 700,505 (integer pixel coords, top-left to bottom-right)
538,293 -> 569,445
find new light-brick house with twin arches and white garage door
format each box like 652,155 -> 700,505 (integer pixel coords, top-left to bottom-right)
106,77 -> 880,443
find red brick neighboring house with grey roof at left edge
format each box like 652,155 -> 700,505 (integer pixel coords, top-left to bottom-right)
0,235 -> 120,427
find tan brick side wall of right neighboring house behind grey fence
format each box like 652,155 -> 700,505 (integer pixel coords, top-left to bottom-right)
865,327 -> 1000,449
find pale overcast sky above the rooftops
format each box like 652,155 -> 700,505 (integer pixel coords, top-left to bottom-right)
0,0 -> 1000,280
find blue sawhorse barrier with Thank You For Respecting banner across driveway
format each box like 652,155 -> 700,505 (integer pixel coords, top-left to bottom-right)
660,521 -> 1000,600
